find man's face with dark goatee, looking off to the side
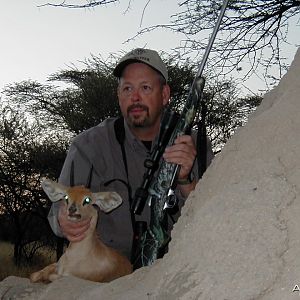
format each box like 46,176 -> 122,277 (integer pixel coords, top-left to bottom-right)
118,63 -> 170,132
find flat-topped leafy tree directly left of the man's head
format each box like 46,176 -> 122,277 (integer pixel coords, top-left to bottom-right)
4,56 -> 120,135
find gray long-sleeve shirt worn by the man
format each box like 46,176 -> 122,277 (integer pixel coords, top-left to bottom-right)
48,118 -> 213,258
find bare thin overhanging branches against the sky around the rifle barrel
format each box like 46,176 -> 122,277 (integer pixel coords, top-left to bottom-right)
45,0 -> 300,88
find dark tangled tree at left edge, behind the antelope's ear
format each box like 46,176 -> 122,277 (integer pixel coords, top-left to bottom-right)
0,106 -> 66,264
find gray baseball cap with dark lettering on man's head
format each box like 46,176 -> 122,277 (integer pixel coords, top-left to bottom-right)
113,48 -> 168,81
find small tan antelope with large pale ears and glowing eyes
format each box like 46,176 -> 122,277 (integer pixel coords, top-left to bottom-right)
30,179 -> 132,282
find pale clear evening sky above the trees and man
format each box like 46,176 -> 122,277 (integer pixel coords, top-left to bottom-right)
0,0 -> 300,96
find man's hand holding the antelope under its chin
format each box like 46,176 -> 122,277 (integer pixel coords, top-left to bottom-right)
58,202 -> 91,242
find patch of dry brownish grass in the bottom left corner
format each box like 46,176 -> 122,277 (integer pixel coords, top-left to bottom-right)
0,241 -> 56,281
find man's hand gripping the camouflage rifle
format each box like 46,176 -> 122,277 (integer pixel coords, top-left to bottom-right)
163,135 -> 197,179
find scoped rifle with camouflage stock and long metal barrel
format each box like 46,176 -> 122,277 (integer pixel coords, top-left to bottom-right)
131,0 -> 229,269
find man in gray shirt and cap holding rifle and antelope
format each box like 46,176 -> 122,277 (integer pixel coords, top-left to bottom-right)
49,49 -> 212,258
